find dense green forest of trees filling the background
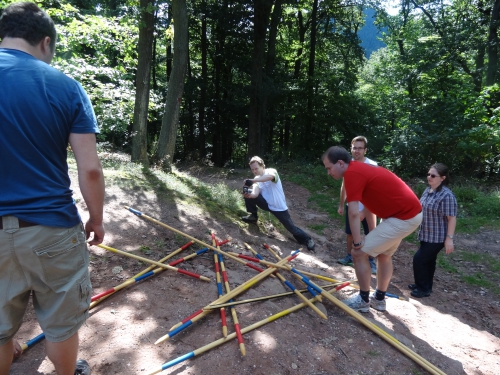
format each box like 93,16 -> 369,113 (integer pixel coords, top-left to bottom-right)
0,0 -> 500,179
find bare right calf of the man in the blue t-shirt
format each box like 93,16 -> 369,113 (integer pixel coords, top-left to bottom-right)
45,332 -> 78,375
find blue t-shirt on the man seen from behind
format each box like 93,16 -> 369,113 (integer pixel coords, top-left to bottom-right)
0,48 -> 99,228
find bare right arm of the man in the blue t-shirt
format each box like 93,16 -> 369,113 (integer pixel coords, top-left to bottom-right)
69,133 -> 104,245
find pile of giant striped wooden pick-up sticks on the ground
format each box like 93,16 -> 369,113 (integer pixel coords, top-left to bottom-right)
17,207 -> 445,375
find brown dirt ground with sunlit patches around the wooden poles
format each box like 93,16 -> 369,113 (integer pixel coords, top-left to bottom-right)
10,159 -> 500,375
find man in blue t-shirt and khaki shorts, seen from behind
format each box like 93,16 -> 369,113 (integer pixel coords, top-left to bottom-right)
0,3 -> 104,375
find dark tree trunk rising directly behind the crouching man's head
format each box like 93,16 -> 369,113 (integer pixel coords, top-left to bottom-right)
248,0 -> 273,157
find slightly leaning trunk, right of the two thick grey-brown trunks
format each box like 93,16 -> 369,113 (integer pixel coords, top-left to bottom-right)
156,0 -> 188,169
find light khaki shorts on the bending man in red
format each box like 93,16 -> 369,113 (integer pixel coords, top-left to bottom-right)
361,212 -> 422,257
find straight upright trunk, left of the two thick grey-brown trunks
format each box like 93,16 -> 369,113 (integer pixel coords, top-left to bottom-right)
132,0 -> 154,164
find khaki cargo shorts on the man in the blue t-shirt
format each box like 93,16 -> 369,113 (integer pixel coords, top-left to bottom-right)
0,216 -> 92,346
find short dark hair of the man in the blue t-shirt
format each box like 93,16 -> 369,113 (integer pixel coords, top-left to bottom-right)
0,2 -> 57,52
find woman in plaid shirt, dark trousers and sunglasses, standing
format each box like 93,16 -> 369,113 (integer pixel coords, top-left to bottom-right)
408,163 -> 457,298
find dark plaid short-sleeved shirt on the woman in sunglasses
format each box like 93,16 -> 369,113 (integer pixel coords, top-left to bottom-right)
418,186 -> 457,243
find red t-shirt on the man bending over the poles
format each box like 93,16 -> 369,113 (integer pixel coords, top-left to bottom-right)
344,161 -> 422,220
